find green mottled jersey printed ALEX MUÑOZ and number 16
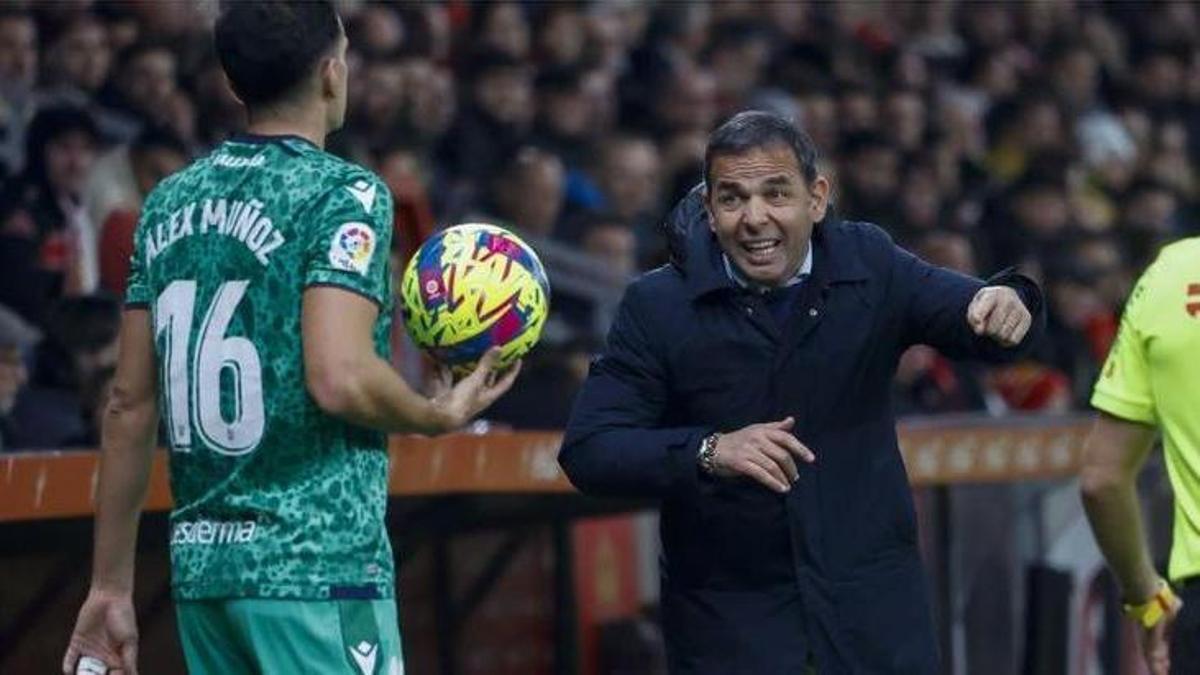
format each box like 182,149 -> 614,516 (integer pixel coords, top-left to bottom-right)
126,137 -> 394,599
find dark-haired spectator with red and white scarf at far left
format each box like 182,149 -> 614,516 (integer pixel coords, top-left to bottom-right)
0,107 -> 98,323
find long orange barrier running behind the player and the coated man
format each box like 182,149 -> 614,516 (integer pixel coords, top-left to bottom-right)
0,417 -> 1091,522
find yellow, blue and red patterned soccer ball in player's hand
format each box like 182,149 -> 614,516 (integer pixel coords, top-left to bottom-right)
401,223 -> 550,375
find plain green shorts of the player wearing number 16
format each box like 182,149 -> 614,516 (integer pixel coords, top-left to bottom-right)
175,598 -> 404,675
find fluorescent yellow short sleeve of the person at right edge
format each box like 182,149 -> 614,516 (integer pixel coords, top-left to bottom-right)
1092,268 -> 1158,424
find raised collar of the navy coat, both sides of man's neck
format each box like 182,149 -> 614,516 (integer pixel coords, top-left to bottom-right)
680,219 -> 870,299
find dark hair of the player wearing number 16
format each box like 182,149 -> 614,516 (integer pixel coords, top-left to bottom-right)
214,0 -> 342,107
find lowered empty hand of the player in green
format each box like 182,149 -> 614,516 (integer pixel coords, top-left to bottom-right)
62,589 -> 138,675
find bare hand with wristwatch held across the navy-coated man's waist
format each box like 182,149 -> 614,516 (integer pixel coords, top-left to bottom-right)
713,417 -> 816,492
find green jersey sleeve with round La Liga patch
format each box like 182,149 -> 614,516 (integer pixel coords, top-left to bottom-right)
305,177 -> 392,306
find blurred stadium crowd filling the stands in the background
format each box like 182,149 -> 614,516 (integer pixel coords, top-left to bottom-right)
0,0 -> 1200,450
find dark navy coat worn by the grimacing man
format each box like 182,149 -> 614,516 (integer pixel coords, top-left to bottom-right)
559,207 -> 1044,675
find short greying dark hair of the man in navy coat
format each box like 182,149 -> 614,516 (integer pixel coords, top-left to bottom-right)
704,110 -> 817,185
